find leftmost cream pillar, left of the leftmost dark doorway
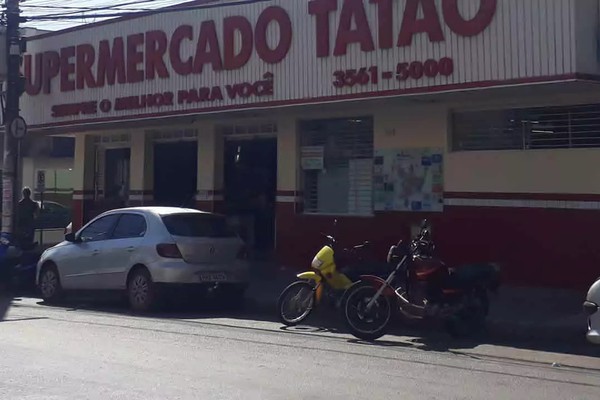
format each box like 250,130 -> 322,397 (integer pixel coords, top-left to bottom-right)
73,134 -> 95,231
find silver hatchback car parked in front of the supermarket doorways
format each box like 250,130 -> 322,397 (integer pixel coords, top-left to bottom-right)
36,207 -> 248,311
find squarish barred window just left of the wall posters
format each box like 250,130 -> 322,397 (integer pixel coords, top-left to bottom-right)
300,117 -> 373,215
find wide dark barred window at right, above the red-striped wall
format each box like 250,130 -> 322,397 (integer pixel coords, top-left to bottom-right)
452,104 -> 600,151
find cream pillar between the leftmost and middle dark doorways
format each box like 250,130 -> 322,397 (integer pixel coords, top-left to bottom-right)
129,132 -> 154,207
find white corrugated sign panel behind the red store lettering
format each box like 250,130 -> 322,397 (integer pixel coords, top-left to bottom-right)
22,0 -> 589,127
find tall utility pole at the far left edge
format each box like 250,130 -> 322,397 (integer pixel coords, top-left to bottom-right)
2,0 -> 26,241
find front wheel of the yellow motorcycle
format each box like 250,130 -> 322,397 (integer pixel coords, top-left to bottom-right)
277,281 -> 315,326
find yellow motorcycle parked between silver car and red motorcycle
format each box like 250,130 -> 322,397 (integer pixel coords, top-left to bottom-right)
277,230 -> 370,326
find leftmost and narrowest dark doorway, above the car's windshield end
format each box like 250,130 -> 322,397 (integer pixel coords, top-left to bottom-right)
104,149 -> 131,207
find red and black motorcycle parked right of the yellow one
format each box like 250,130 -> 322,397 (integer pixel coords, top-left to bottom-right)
343,220 -> 500,341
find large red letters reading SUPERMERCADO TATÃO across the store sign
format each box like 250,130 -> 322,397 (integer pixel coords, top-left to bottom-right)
25,0 -> 497,95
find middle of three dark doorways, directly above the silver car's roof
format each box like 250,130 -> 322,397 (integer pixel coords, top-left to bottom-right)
154,142 -> 198,207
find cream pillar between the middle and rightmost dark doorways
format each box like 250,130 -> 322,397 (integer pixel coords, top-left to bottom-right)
196,123 -> 224,212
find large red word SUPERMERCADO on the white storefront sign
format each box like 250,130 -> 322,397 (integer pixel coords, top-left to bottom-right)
25,7 -> 292,95
